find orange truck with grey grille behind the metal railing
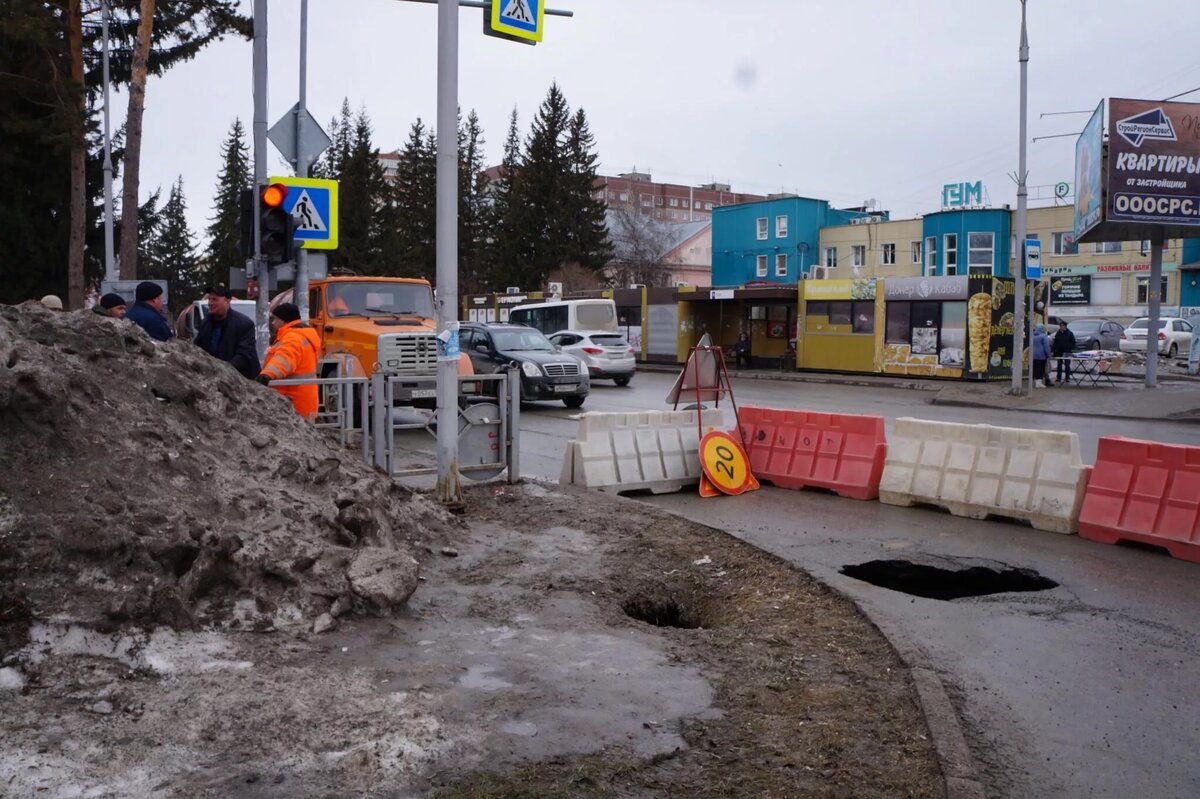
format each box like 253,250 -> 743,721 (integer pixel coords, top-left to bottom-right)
271,276 -> 474,408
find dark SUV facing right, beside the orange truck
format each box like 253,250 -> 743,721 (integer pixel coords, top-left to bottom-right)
458,322 -> 590,408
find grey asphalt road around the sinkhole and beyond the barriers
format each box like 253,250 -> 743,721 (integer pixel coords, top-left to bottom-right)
494,373 -> 1200,799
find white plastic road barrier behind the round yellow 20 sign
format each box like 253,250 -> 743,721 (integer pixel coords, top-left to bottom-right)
559,408 -> 724,494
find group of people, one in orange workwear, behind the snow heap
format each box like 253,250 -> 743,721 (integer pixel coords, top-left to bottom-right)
42,281 -> 320,420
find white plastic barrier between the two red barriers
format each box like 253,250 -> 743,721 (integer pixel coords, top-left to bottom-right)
880,419 -> 1091,534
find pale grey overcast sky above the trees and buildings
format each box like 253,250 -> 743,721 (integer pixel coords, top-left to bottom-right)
126,0 -> 1200,242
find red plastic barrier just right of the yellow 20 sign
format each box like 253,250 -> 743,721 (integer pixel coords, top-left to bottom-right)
738,405 -> 888,499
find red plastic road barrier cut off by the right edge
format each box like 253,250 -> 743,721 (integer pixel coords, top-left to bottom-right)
1079,435 -> 1200,563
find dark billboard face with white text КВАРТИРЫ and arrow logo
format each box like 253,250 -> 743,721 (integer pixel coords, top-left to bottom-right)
1104,97 -> 1200,226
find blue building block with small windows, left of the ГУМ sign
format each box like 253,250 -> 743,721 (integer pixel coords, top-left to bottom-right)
712,197 -> 886,286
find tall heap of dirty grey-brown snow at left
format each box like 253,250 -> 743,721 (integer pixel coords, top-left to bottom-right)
0,302 -> 458,659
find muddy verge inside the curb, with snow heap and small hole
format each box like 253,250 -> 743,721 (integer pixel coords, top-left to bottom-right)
0,306 -> 943,799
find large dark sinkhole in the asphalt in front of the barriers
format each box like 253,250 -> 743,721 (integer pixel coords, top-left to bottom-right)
841,560 -> 1058,600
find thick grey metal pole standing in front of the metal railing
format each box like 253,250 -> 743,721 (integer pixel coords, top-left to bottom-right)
437,0 -> 462,503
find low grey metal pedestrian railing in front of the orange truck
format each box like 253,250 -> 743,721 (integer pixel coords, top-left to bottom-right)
271,370 -> 521,483
